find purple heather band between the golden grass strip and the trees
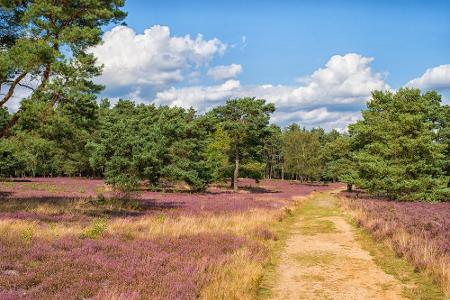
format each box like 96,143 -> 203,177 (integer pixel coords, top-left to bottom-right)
0,178 -> 339,222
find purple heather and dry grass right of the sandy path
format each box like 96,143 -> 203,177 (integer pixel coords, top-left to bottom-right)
342,193 -> 450,292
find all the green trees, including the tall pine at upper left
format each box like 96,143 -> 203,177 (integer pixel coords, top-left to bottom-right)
0,0 -> 450,200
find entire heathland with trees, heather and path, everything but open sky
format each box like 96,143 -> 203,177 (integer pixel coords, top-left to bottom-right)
0,0 -> 450,299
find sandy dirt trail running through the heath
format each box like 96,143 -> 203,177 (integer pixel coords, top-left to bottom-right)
273,193 -> 403,299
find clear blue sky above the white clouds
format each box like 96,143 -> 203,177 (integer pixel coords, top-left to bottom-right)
121,0 -> 450,86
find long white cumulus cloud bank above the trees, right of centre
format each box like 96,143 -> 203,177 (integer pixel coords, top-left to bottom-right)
150,53 -> 389,130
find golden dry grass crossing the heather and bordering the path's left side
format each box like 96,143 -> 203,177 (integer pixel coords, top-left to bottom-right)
0,198 -> 310,299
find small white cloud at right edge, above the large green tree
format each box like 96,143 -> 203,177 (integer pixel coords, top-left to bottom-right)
406,64 -> 450,90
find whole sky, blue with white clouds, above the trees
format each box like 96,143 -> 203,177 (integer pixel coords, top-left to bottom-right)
86,0 -> 450,130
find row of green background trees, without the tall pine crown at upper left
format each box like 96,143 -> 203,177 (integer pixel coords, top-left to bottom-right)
0,89 -> 450,200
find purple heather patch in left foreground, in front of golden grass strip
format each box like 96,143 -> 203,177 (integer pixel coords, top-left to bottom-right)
0,234 -> 244,299
